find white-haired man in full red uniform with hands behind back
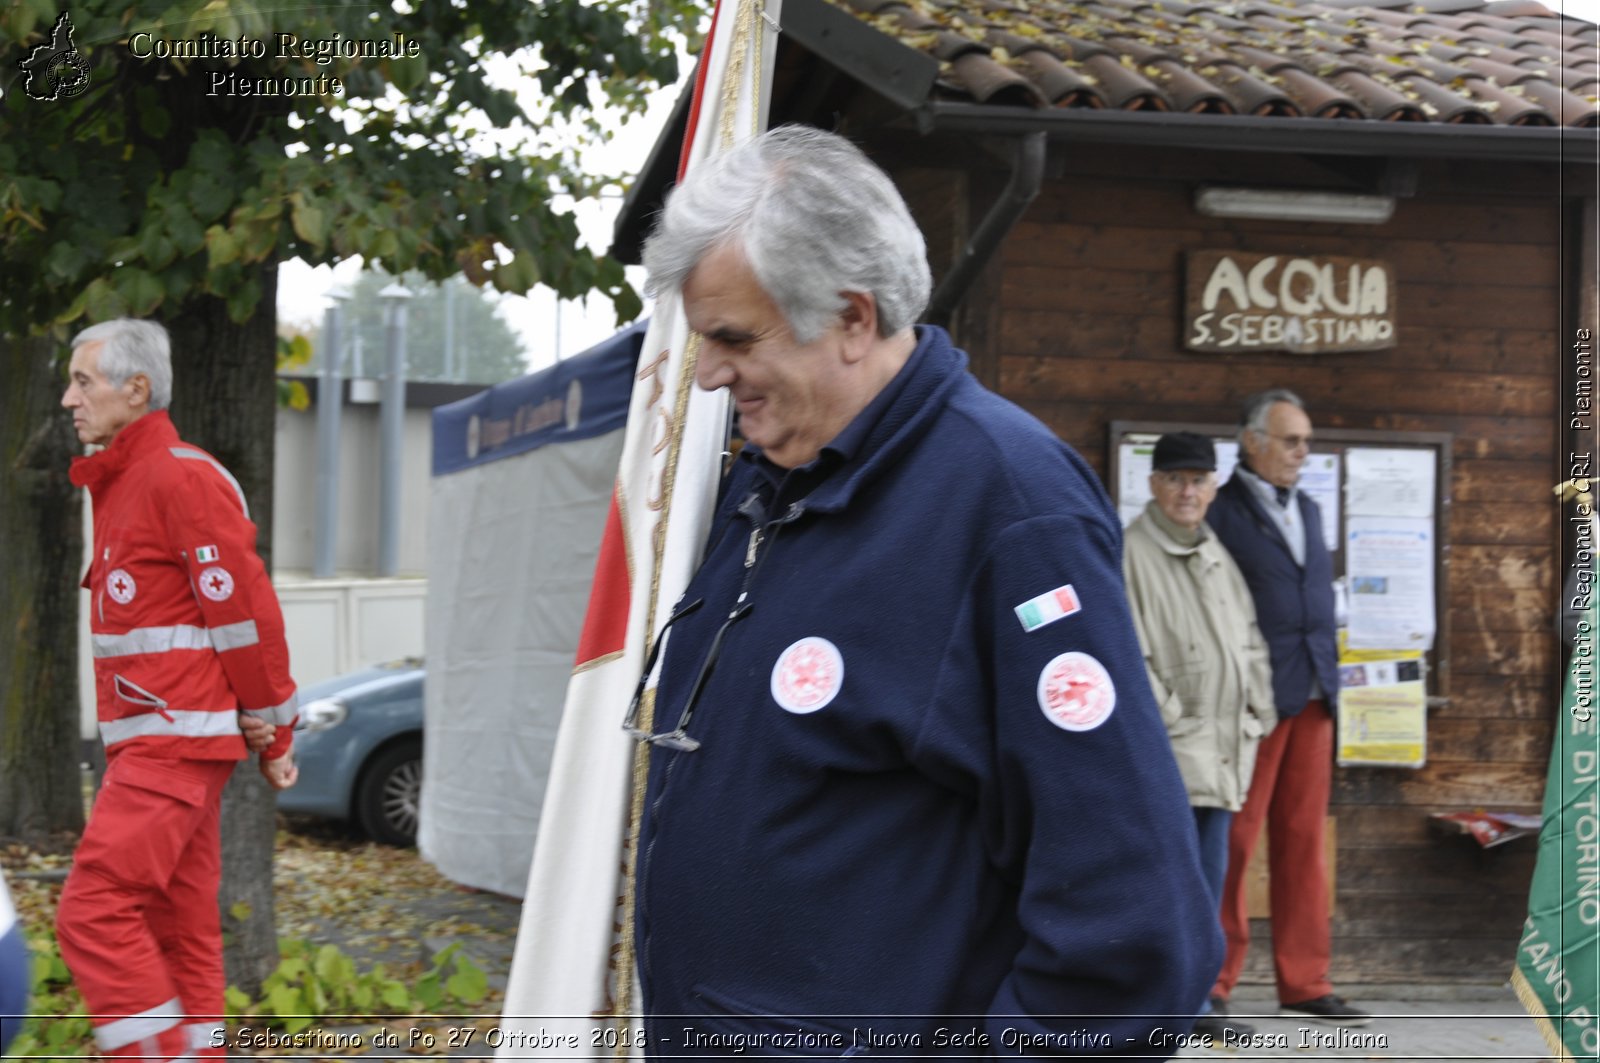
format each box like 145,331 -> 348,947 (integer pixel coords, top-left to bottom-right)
56,319 -> 298,1060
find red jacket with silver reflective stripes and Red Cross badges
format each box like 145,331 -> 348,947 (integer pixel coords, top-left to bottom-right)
72,411 -> 296,760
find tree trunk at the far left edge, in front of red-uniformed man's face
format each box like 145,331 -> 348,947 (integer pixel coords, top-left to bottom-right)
0,336 -> 83,837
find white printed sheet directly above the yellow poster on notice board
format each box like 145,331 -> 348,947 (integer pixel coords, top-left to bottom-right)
1344,517 -> 1434,650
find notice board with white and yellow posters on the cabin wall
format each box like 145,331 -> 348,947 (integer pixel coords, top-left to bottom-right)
1109,421 -> 1453,768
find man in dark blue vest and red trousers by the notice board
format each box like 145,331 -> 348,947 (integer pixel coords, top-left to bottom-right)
1206,387 -> 1370,1026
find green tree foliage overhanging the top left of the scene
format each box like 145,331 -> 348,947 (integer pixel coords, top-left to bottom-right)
0,0 -> 698,335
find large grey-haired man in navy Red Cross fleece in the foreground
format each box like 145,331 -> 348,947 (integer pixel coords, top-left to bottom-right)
635,128 -> 1221,1058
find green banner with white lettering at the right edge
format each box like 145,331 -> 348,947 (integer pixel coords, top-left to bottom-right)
1512,573 -> 1600,1060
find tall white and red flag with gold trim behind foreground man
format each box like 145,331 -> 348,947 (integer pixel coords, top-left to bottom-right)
498,0 -> 781,1058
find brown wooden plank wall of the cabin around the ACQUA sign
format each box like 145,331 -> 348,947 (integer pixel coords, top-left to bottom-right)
904,146 -> 1565,983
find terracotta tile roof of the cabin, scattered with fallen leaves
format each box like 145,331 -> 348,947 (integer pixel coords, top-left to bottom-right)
832,0 -> 1600,126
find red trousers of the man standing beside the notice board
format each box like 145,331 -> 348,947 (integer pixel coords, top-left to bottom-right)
1214,700 -> 1333,1004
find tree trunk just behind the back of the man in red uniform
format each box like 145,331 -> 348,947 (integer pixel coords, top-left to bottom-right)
163,263 -> 278,996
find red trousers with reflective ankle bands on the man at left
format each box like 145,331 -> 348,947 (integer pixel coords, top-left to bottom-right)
56,748 -> 237,1060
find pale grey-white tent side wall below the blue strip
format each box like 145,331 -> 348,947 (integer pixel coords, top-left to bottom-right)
418,429 -> 622,897
